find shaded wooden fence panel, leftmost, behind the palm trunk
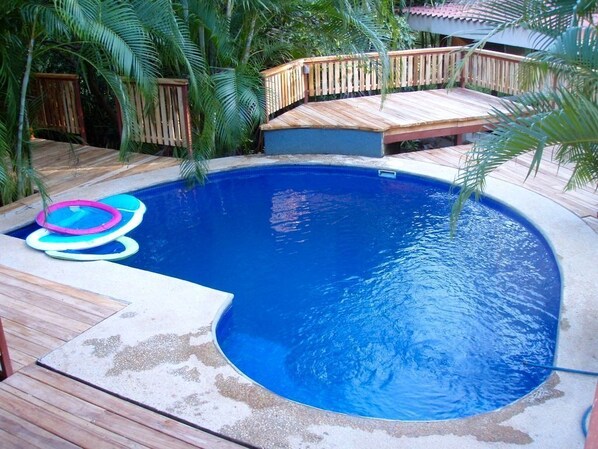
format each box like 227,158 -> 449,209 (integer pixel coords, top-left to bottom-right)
32,73 -> 87,142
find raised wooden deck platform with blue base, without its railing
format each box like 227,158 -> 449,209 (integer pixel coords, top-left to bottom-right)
261,88 -> 504,157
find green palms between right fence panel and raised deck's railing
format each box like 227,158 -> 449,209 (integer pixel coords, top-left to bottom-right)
181,0 -> 408,155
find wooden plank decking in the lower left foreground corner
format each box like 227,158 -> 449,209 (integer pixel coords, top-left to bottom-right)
0,266 -> 248,449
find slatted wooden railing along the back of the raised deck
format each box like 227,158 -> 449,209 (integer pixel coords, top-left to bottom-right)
262,47 -> 523,117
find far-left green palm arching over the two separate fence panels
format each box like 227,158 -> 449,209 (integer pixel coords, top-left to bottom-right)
0,0 -> 206,204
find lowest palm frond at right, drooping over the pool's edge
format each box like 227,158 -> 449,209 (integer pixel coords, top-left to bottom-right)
452,88 -> 598,228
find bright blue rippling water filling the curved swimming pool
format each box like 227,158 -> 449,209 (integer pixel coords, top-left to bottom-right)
9,166 -> 561,420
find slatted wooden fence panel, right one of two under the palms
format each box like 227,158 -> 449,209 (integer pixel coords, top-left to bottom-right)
119,78 -> 192,149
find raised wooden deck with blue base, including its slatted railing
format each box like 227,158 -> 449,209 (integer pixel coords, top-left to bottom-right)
261,47 -> 528,157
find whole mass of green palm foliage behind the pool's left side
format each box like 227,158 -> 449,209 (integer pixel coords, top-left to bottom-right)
0,0 -> 408,204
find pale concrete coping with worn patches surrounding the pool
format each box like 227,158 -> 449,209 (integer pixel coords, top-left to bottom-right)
0,155 -> 598,448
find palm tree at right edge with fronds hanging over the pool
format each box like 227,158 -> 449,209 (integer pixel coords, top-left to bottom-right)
452,0 -> 598,228
